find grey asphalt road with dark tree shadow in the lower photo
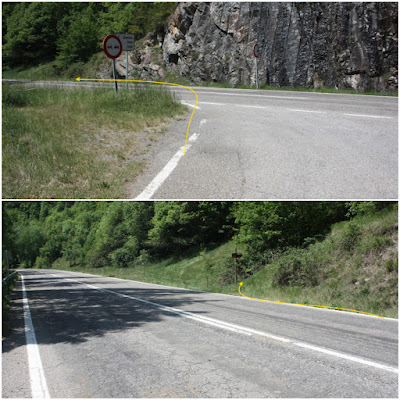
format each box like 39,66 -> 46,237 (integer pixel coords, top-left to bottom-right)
3,270 -> 398,398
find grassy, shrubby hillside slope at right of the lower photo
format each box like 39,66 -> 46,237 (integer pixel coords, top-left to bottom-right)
244,211 -> 398,316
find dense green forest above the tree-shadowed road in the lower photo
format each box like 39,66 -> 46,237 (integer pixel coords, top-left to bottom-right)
3,201 -> 394,273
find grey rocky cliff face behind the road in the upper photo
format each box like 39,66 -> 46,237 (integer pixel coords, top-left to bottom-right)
115,2 -> 398,91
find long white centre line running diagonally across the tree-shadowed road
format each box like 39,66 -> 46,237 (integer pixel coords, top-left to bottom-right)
55,274 -> 399,374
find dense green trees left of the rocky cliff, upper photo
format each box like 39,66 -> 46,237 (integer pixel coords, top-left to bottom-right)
2,2 -> 176,68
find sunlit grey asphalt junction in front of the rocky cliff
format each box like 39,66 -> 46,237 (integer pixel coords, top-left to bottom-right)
130,88 -> 398,200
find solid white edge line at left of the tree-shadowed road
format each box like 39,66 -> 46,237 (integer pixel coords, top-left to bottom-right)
21,275 -> 50,399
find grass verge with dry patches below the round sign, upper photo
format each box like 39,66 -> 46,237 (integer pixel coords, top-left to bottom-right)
2,85 -> 186,199
